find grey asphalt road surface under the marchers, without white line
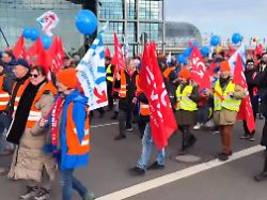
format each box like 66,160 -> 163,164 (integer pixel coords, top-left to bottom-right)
0,113 -> 267,200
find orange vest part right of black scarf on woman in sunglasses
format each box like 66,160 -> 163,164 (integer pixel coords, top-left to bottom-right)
26,82 -> 57,128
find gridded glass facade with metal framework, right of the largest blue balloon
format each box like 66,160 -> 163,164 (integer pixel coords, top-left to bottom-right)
97,0 -> 165,53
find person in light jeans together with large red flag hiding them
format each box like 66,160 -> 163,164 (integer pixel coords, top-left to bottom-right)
130,43 -> 177,175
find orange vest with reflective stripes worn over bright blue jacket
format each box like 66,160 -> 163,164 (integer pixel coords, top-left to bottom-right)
66,103 -> 91,155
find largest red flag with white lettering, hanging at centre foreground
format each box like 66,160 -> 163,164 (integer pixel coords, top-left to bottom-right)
140,44 -> 177,149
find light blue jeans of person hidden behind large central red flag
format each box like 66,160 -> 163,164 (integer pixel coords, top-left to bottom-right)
137,123 -> 165,169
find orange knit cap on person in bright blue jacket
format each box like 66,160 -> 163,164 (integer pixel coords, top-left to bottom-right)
56,68 -> 79,89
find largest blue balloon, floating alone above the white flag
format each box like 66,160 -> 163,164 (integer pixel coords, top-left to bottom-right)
75,10 -> 97,35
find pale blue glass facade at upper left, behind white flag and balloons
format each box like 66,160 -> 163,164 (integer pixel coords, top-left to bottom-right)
0,0 -> 83,50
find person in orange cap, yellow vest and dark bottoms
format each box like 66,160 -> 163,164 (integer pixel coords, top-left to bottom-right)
175,68 -> 199,154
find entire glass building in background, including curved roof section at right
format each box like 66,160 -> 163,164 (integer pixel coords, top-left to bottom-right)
0,0 -> 201,53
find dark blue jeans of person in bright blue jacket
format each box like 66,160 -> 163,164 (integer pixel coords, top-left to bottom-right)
61,169 -> 88,200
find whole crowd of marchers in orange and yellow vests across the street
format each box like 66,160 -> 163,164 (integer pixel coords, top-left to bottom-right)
0,44 -> 267,200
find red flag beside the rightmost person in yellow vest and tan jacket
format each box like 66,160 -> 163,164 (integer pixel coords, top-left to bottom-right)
233,55 -> 255,132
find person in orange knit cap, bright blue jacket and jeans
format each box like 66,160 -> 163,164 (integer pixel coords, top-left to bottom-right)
56,68 -> 95,200
